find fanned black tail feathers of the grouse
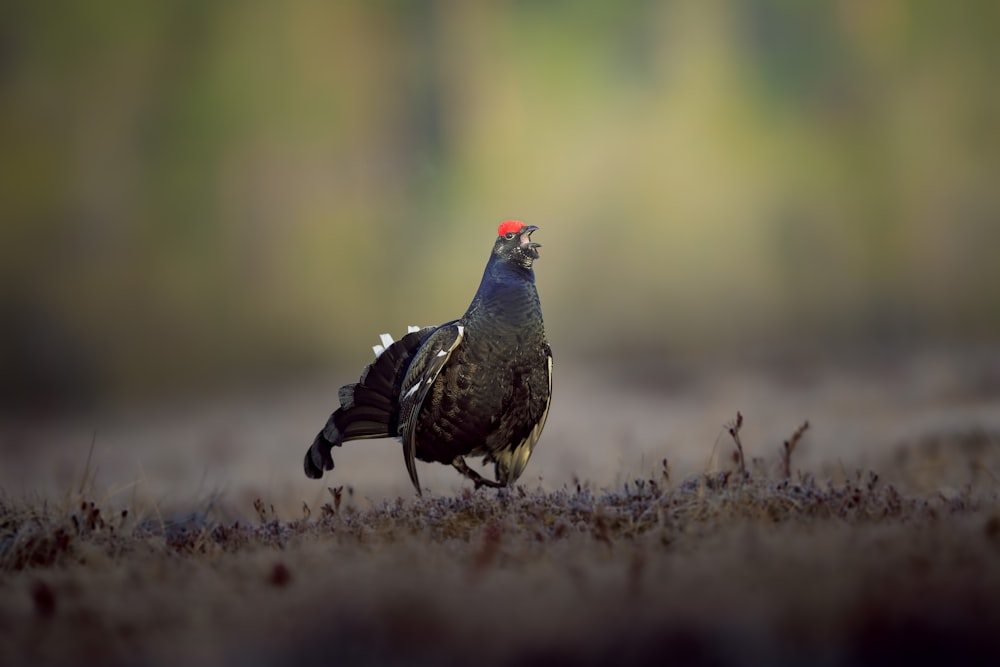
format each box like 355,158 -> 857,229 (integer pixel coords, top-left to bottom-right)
304,327 -> 434,479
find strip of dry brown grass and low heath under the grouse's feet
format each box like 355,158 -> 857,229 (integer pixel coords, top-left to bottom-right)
0,416 -> 1000,665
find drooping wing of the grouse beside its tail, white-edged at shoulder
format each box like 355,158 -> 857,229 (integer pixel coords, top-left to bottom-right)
399,320 -> 465,495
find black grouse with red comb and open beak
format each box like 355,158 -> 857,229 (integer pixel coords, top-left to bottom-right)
304,220 -> 552,496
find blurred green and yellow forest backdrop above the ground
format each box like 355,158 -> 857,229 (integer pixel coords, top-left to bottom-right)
0,0 -> 1000,406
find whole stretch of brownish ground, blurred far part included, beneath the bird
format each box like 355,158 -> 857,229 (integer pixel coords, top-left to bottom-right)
0,348 -> 1000,665
